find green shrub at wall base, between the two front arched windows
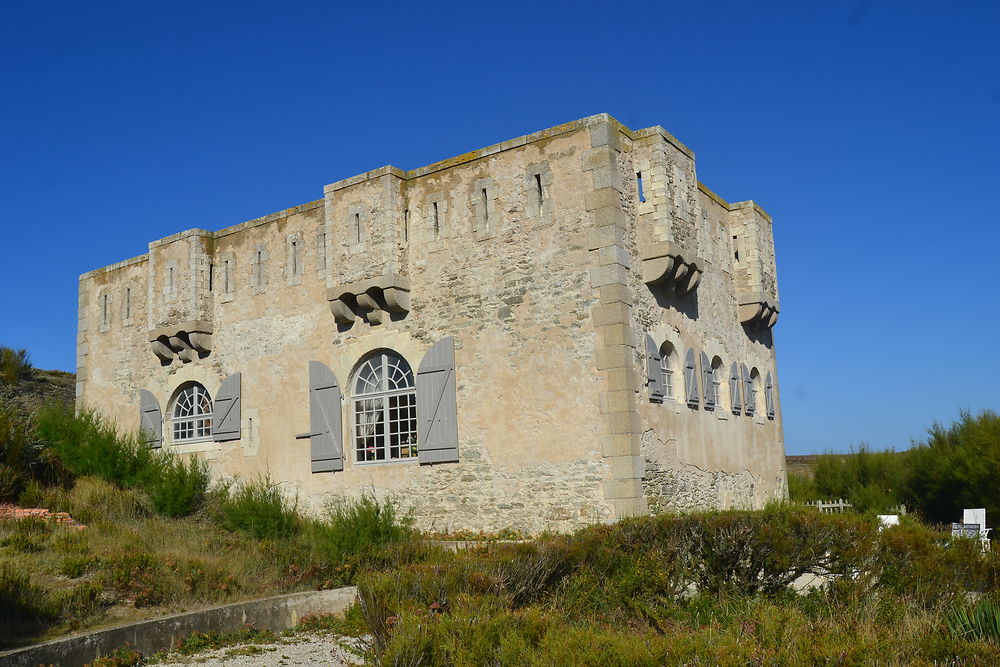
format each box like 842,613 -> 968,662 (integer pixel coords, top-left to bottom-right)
213,477 -> 302,539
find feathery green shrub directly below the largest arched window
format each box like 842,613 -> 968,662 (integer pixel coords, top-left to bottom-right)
309,492 -> 413,563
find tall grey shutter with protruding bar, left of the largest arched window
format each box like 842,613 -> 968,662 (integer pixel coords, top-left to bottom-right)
296,361 -> 344,472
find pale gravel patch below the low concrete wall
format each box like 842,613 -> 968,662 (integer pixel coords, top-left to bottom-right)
157,633 -> 364,667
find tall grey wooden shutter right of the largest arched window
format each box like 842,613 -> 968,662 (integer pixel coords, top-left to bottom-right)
417,336 -> 458,464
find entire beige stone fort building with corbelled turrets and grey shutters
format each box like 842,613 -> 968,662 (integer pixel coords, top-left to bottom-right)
77,114 -> 786,531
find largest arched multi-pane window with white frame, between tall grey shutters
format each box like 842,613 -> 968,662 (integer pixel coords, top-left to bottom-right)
351,350 -> 417,463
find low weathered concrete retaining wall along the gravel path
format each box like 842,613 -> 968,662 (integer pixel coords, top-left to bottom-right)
0,586 -> 358,667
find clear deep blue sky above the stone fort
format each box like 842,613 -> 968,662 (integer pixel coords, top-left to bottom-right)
0,0 -> 1000,453
